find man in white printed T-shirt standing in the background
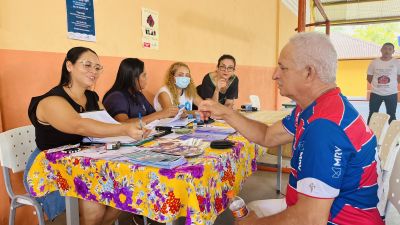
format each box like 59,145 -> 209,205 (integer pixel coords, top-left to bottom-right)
367,43 -> 400,124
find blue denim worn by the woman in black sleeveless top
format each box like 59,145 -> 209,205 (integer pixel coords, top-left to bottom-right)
24,148 -> 65,220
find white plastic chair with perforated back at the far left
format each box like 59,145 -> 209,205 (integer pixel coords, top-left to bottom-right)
0,126 -> 45,225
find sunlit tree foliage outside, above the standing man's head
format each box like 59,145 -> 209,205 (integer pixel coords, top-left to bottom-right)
316,22 -> 400,47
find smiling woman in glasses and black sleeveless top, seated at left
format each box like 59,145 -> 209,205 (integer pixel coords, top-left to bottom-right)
24,47 -> 149,225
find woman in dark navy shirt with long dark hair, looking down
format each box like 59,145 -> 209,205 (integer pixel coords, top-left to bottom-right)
103,58 -> 178,123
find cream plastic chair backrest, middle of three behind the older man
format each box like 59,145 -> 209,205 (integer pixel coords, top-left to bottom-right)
379,120 -> 400,168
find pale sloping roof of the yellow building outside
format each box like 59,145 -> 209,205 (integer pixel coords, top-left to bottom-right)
330,32 -> 400,59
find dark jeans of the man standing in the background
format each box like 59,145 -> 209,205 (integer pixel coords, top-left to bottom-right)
368,92 -> 397,124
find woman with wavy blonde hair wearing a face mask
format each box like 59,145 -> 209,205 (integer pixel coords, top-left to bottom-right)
154,62 -> 202,114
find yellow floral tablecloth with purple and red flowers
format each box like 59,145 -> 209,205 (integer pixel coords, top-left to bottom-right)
28,134 -> 265,225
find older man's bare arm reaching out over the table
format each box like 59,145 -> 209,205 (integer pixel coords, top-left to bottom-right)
199,100 -> 293,147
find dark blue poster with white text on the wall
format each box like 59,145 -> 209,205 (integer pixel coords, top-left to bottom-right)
66,0 -> 96,42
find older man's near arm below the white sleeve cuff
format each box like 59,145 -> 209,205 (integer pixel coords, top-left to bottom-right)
237,193 -> 333,225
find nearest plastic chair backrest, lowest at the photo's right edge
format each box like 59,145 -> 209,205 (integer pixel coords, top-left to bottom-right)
385,148 -> 400,213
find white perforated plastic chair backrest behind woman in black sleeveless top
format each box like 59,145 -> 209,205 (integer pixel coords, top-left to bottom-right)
0,125 -> 36,173
